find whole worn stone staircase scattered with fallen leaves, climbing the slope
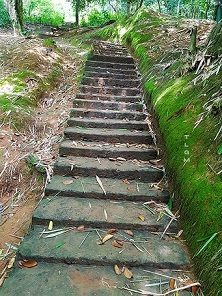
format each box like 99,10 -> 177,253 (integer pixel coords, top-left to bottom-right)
0,42 -> 193,296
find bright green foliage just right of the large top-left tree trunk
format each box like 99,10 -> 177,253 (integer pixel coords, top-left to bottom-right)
24,0 -> 64,26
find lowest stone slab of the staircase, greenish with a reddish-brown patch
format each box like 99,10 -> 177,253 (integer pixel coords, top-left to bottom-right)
1,264 -> 190,296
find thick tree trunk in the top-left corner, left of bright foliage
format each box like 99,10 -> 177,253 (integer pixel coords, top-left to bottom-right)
4,0 -> 23,35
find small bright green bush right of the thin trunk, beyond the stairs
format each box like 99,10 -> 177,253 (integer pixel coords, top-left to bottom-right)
80,9 -> 115,27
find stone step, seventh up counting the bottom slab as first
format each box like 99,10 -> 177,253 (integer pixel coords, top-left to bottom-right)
64,126 -> 153,145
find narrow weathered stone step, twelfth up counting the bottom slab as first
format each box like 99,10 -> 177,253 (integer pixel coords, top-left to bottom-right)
80,85 -> 140,97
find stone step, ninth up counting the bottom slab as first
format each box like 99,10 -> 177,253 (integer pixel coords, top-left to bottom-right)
70,108 -> 146,121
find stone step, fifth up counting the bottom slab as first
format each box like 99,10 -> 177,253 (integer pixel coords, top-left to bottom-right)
53,156 -> 163,182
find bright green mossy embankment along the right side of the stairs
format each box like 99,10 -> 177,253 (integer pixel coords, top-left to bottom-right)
75,11 -> 222,296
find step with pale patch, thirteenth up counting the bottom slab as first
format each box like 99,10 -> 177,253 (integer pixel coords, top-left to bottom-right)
82,77 -> 140,88
